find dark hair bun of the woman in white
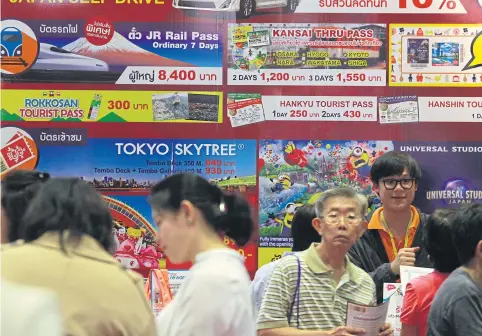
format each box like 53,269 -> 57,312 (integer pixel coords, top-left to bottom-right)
217,194 -> 254,246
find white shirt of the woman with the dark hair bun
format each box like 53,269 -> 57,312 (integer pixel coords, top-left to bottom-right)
158,248 -> 256,336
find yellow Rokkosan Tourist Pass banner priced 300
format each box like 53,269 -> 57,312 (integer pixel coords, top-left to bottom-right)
1,90 -> 223,123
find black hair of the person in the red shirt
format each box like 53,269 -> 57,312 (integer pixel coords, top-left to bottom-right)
424,209 -> 460,273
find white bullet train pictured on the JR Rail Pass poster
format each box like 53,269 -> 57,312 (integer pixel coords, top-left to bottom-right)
31,43 -> 109,72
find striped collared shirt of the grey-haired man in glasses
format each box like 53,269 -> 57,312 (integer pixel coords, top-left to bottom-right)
257,244 -> 376,331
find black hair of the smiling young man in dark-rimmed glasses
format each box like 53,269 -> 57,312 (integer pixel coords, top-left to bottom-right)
370,151 -> 422,185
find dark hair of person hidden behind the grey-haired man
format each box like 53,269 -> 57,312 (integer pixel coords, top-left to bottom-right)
291,204 -> 321,252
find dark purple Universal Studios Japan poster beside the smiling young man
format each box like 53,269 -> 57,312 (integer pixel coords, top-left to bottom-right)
395,142 -> 482,213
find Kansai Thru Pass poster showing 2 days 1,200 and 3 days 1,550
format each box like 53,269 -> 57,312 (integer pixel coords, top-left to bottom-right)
228,23 -> 387,86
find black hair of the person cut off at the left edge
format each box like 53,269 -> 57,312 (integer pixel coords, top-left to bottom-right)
1,169 -> 50,242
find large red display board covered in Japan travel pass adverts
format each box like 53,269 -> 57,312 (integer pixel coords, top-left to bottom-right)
0,0 -> 482,275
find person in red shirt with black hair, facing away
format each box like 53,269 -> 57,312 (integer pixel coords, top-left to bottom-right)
400,209 -> 460,336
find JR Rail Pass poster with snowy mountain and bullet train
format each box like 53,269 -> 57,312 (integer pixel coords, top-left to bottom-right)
1,18 -> 223,85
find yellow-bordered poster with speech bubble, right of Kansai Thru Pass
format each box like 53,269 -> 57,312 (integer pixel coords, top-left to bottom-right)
389,24 -> 482,87
